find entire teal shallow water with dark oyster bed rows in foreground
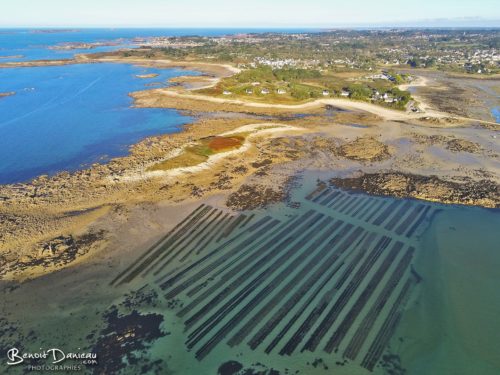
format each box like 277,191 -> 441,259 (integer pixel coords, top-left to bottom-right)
0,178 -> 500,375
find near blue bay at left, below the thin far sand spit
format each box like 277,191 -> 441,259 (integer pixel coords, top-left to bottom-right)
0,63 -> 201,183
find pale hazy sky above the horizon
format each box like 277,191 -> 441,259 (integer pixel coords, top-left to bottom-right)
0,0 -> 500,28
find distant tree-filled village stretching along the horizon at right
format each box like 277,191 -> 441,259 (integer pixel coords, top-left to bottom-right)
133,29 -> 500,75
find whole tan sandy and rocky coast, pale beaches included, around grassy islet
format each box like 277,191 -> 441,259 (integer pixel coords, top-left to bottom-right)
0,54 -> 500,279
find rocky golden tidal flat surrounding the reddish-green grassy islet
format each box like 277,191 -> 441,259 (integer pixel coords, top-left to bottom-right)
0,103 -> 500,277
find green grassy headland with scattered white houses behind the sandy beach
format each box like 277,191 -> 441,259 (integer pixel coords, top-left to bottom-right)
199,64 -> 412,112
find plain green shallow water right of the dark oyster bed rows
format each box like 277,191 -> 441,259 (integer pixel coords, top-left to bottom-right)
393,206 -> 500,375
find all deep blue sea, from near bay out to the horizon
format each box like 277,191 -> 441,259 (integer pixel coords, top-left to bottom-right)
0,29 -> 314,184
